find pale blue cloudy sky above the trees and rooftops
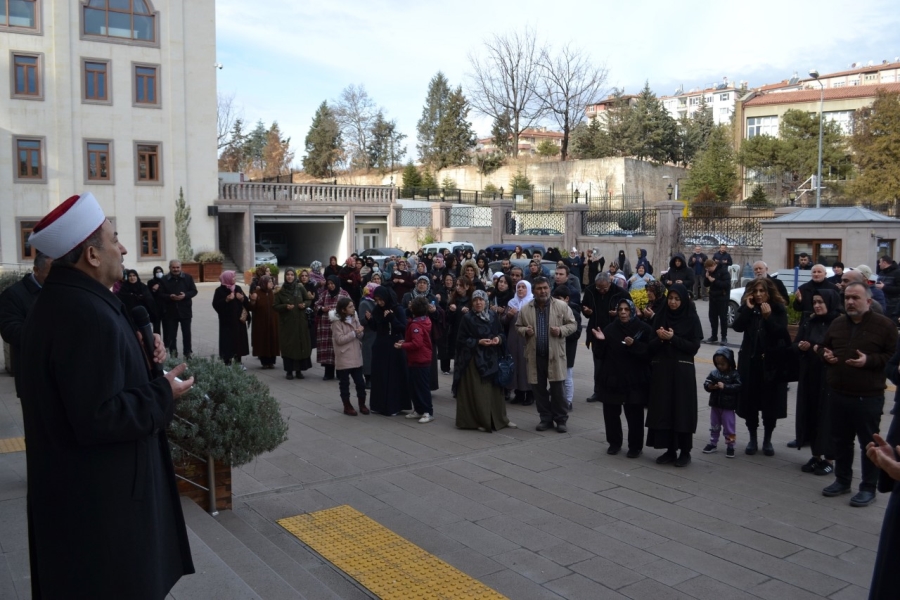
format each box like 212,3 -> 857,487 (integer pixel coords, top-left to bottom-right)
216,0 -> 900,165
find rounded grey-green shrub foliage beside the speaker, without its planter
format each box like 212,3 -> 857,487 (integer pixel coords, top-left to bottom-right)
166,357 -> 288,467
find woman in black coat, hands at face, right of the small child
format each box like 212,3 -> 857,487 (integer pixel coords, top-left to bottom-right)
732,279 -> 791,456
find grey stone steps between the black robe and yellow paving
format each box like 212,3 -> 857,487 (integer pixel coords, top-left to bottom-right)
170,498 -> 374,600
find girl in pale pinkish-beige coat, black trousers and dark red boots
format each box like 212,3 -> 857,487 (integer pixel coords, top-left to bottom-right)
328,296 -> 369,417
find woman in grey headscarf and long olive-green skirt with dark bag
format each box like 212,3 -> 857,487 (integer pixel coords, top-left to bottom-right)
453,290 -> 515,432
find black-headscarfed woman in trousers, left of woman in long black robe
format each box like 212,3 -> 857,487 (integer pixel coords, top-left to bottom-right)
591,298 -> 654,458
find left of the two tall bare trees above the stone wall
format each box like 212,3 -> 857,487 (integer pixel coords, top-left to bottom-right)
468,28 -> 544,156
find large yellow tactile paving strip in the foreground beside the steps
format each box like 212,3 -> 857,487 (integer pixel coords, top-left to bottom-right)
278,505 -> 505,600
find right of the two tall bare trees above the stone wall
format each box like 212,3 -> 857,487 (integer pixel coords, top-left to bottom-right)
536,44 -> 608,160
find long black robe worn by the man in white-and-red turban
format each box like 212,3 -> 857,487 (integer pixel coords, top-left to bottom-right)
22,266 -> 194,599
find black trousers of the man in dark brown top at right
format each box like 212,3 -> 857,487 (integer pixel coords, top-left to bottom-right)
829,390 -> 884,492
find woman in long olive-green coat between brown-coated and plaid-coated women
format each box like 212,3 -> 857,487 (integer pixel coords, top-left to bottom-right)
272,269 -> 315,379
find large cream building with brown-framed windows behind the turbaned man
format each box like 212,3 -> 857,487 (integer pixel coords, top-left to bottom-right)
0,0 -> 218,273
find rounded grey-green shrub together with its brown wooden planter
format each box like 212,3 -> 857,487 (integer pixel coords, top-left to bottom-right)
167,357 -> 288,512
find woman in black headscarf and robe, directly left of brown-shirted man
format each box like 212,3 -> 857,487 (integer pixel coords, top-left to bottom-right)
794,289 -> 841,475
